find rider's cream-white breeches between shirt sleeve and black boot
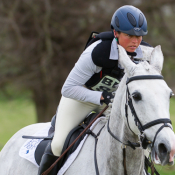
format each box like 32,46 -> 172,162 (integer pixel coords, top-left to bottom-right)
51,96 -> 106,156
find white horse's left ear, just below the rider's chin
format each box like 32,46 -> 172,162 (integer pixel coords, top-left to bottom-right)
118,45 -> 136,75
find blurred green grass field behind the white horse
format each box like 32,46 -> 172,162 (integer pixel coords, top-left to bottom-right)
0,98 -> 175,175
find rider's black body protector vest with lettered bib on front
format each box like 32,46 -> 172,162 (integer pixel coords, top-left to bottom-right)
85,31 -> 151,92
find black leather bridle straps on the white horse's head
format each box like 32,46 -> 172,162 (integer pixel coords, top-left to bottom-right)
108,75 -> 172,149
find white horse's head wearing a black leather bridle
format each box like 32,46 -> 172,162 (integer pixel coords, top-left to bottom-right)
119,46 -> 175,165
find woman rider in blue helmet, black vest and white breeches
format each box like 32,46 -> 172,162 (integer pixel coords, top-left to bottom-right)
38,5 -> 150,175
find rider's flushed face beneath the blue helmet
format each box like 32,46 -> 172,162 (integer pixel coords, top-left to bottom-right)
114,31 -> 142,52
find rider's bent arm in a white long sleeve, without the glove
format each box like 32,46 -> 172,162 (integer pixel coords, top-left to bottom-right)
62,40 -> 102,105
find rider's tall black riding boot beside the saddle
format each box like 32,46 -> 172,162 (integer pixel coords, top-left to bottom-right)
38,142 -> 58,175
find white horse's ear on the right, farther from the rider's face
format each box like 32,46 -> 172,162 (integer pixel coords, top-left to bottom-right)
150,45 -> 164,73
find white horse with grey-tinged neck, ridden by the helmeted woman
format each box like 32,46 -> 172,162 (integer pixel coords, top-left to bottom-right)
0,46 -> 175,175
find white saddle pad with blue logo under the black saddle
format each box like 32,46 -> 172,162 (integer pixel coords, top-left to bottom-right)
19,117 -> 105,175
